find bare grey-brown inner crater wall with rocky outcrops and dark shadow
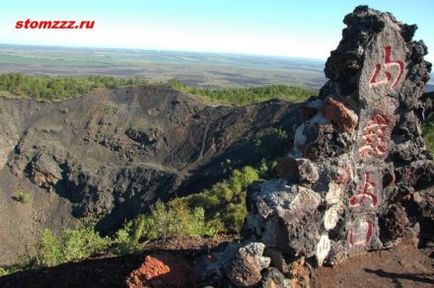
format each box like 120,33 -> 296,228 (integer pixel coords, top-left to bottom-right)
0,86 -> 300,264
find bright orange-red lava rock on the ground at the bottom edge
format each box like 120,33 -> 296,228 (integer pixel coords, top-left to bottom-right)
126,254 -> 192,288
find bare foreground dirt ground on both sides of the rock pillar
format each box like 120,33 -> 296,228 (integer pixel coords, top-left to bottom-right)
0,236 -> 434,288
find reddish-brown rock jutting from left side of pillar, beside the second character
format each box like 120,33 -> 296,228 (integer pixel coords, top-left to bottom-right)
321,98 -> 359,132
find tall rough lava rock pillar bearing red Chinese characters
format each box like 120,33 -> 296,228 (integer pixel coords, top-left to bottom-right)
247,6 -> 434,265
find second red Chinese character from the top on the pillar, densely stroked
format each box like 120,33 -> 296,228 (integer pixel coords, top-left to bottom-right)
359,114 -> 389,160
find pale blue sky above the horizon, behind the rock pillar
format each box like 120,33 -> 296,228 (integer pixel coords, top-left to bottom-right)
0,0 -> 434,61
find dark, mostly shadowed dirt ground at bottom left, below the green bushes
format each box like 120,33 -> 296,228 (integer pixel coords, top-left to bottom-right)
0,235 -> 237,288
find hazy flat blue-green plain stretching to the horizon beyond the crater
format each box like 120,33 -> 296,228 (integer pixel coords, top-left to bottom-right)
0,44 -> 434,91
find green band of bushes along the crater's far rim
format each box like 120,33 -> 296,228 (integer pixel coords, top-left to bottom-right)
0,73 -> 313,105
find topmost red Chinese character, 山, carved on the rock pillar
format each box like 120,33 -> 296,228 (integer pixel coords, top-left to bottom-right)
369,46 -> 404,88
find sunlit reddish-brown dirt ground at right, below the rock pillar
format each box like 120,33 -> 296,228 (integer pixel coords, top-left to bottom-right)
313,244 -> 434,288
